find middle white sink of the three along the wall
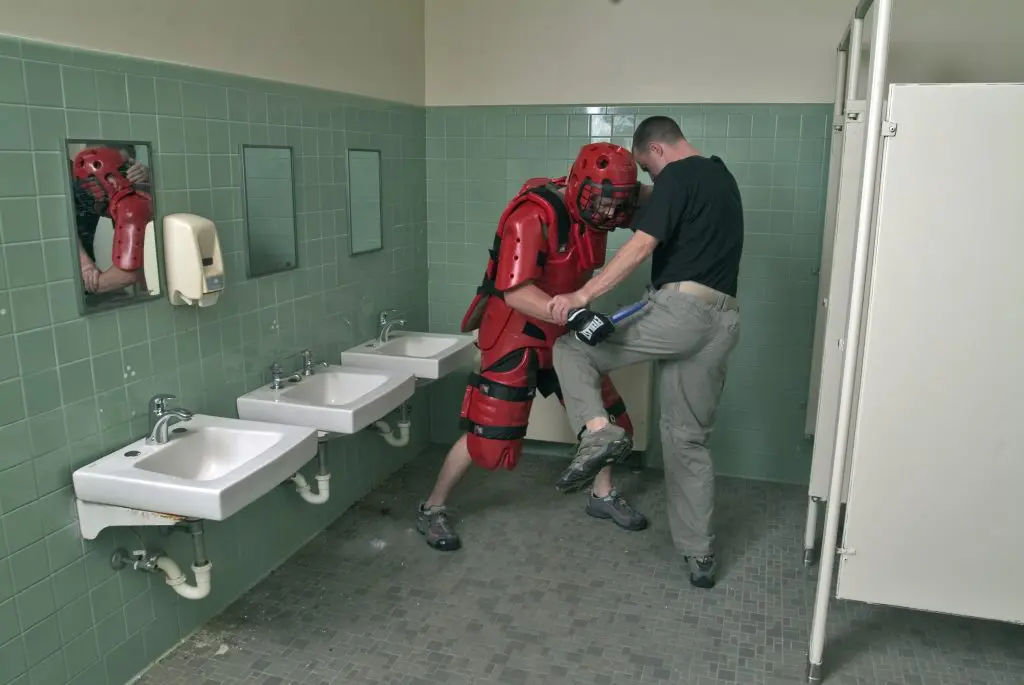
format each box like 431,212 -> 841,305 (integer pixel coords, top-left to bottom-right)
237,366 -> 416,434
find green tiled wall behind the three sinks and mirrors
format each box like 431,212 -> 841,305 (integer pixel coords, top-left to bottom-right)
0,37 -> 429,685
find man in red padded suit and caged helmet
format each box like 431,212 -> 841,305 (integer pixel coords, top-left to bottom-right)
417,142 -> 647,551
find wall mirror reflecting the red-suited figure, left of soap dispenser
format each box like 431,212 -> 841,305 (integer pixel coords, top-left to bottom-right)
66,140 -> 160,314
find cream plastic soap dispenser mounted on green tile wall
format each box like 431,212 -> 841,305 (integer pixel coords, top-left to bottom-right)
164,213 -> 224,307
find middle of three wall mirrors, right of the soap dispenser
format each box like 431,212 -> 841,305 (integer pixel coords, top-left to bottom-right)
242,145 -> 299,279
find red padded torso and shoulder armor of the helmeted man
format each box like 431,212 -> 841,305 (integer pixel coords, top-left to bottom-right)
462,178 -> 607,368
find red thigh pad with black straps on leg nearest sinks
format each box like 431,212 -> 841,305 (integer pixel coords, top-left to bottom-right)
462,349 -> 537,471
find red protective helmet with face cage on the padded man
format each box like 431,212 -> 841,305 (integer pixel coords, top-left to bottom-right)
565,142 -> 640,230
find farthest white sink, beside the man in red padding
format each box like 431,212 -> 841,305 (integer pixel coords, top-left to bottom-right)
341,331 -> 476,381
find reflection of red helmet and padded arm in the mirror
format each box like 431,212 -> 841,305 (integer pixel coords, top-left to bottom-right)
72,147 -> 153,271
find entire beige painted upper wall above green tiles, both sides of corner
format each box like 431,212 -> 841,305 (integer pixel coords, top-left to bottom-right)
6,0 -> 1024,105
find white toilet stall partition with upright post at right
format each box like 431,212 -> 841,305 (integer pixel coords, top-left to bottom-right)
808,0 -> 1024,682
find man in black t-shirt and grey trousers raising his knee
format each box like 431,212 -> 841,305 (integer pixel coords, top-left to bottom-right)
549,117 -> 743,588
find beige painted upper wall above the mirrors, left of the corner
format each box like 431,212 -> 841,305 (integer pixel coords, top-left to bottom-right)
0,0 -> 424,104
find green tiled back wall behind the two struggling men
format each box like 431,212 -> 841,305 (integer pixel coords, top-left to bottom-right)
426,104 -> 830,483
